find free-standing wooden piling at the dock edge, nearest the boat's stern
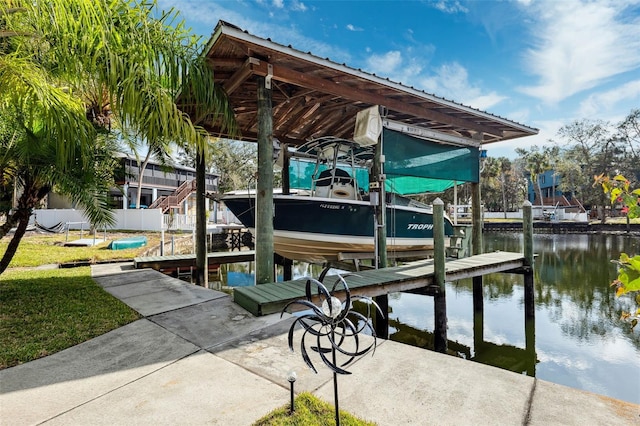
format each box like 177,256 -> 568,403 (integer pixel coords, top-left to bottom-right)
433,198 -> 447,353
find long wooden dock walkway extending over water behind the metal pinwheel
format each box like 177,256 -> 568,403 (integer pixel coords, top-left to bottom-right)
233,252 -> 525,316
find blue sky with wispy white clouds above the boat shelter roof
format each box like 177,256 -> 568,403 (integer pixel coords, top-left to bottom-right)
158,0 -> 640,158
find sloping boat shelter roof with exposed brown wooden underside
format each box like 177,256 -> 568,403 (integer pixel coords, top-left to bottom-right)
185,21 -> 538,145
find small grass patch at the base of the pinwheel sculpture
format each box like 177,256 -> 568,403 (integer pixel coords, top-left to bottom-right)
253,392 -> 375,426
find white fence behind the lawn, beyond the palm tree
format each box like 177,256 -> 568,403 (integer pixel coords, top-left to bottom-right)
32,209 -> 163,231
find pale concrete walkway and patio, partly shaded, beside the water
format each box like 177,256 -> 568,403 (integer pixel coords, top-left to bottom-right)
0,264 -> 640,426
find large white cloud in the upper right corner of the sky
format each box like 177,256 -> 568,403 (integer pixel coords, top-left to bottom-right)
519,0 -> 640,103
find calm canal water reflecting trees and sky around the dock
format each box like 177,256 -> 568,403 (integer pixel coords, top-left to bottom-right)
216,233 -> 640,403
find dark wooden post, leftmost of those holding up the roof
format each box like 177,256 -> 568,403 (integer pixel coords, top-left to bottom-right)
195,147 -> 209,288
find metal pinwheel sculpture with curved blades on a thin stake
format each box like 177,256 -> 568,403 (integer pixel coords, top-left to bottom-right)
280,274 -> 384,425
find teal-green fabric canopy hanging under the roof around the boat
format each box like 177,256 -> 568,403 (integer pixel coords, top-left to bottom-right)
289,128 -> 480,195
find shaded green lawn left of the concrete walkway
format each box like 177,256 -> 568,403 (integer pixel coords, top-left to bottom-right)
0,267 -> 139,369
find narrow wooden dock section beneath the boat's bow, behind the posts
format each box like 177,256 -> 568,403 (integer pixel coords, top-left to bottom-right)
133,250 -> 256,271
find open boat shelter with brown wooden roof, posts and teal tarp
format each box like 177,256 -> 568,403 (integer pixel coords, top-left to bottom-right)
183,21 -> 538,350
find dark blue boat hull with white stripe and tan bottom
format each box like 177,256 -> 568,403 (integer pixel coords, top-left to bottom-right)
224,195 -> 453,263
